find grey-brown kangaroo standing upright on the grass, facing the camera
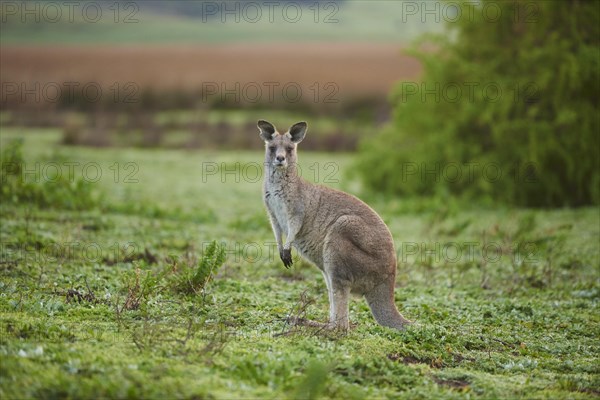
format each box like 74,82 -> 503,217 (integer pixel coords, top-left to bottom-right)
258,120 -> 411,330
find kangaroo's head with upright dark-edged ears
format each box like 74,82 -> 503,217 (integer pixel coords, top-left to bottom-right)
258,120 -> 307,170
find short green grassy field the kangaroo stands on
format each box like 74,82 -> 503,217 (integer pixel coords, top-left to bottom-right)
0,128 -> 600,399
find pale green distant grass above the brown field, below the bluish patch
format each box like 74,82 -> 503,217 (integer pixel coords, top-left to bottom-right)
0,0 -> 440,45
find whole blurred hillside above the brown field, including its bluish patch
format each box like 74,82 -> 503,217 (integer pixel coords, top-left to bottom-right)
0,0 -> 441,45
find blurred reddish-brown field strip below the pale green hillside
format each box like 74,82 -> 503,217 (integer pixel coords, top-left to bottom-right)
0,43 -> 421,99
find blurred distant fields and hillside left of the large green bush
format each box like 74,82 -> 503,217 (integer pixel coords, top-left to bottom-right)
1,1 -> 428,151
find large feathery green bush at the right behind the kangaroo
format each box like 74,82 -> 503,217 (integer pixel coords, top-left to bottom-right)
357,0 -> 600,207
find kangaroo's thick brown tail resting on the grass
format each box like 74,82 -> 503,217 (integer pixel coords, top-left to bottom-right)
365,280 -> 412,330
